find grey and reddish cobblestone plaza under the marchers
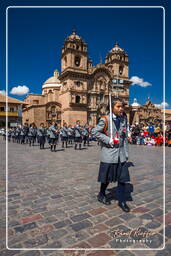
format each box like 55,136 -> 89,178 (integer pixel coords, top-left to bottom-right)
0,138 -> 171,256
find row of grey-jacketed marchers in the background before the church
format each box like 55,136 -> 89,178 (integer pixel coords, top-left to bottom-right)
3,120 -> 93,152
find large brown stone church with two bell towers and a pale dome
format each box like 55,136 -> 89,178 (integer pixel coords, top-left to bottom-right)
23,31 -> 131,125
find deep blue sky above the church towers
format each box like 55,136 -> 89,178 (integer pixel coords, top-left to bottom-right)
0,0 -> 171,107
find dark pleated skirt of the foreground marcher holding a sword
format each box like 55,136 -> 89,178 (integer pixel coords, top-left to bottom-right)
98,162 -> 130,183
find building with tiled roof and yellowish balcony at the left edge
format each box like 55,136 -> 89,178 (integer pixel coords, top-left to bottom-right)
0,94 -> 26,128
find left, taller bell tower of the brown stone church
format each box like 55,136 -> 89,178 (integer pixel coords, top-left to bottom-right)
60,31 -> 89,125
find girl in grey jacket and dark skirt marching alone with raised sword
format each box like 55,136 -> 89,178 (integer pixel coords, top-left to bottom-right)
92,99 -> 130,212
